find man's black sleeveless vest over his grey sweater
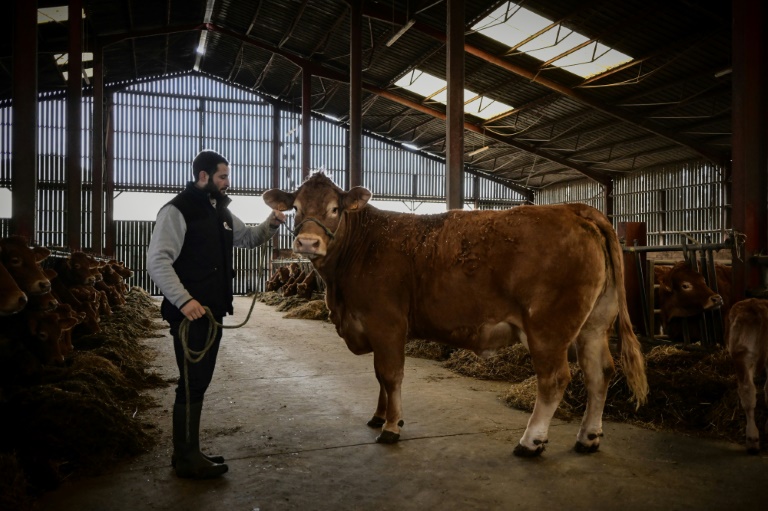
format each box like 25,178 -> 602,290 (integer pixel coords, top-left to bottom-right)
161,182 -> 234,322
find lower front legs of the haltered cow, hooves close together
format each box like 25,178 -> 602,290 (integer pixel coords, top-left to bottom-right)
368,346 -> 405,444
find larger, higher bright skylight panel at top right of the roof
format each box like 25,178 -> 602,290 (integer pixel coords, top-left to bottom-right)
472,2 -> 632,78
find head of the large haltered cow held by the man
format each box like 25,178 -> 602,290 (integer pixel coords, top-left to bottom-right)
264,172 -> 371,259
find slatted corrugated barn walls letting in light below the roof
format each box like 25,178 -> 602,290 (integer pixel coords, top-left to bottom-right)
0,75 -> 727,293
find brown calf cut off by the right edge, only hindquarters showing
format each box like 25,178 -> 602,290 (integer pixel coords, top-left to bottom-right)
727,298 -> 768,454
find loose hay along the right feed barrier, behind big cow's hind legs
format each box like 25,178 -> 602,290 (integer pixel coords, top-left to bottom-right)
444,345 -> 768,442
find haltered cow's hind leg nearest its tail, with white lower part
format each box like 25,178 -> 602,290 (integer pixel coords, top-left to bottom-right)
575,325 -> 616,453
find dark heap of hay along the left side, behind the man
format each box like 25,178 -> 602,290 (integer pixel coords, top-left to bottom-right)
0,288 -> 167,510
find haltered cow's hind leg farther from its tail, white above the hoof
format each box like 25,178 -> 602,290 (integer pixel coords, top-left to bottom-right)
514,350 -> 571,458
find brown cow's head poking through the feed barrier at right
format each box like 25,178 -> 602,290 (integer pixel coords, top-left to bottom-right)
659,262 -> 723,321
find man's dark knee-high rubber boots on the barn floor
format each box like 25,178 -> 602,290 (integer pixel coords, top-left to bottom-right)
171,403 -> 229,479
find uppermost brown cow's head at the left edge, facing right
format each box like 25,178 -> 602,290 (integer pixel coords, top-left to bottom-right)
0,236 -> 51,295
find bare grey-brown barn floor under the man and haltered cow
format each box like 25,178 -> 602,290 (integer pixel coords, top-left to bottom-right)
35,298 -> 768,511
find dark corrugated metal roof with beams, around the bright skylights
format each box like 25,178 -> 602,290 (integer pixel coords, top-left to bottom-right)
0,0 -> 732,190
